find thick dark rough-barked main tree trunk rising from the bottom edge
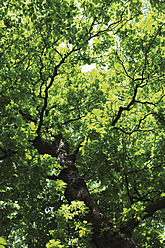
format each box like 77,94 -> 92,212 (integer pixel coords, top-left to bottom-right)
33,135 -> 140,248
